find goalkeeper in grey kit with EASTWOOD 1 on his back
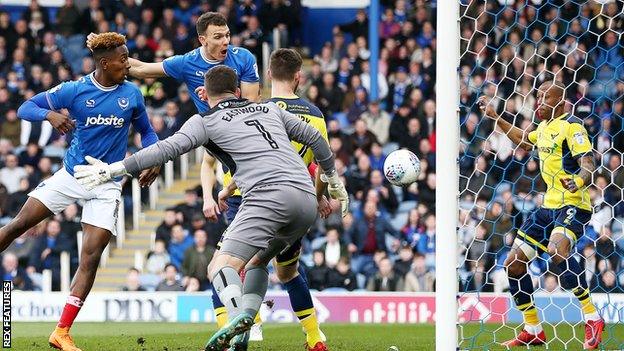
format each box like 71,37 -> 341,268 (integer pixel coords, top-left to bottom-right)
74,65 -> 348,351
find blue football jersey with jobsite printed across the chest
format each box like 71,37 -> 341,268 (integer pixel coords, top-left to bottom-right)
45,73 -> 151,175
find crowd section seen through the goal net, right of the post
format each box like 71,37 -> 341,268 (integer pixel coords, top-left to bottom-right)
459,1 -> 624,292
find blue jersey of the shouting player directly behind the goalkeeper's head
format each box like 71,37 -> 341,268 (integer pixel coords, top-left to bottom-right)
163,45 -> 260,113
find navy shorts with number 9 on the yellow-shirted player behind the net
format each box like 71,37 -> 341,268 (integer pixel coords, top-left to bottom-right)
516,206 -> 592,259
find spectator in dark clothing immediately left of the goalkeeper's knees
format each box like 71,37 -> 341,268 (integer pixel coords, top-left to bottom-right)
182,229 -> 215,290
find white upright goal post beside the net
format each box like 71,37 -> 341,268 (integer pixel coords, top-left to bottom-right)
435,0 -> 459,351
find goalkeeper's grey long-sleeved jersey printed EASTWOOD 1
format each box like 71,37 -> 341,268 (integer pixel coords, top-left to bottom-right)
124,99 -> 334,195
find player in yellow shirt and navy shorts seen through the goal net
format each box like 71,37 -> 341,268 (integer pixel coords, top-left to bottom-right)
479,82 -> 605,350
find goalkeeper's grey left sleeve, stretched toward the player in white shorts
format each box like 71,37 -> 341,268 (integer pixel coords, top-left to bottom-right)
123,115 -> 208,174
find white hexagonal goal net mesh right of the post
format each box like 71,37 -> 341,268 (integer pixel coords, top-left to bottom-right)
456,0 -> 624,350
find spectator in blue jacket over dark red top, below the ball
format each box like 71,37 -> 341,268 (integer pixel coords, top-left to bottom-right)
345,201 -> 398,276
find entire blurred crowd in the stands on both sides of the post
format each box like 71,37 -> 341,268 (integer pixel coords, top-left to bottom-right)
0,0 -> 624,298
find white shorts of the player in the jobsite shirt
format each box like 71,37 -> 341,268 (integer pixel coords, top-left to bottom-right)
28,167 -> 121,235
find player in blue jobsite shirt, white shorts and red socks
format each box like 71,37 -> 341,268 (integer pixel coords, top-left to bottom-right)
0,33 -> 160,351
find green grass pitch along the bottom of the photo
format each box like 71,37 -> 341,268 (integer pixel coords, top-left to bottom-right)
7,323 -> 624,351
